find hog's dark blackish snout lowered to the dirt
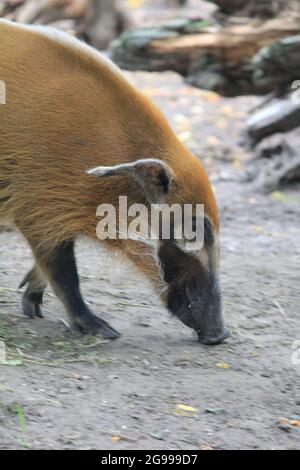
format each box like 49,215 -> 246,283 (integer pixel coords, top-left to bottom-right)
159,244 -> 230,344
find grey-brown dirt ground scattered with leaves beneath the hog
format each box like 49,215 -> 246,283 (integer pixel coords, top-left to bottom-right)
0,69 -> 300,449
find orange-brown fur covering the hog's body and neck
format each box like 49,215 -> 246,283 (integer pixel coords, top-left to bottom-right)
0,20 -> 219,269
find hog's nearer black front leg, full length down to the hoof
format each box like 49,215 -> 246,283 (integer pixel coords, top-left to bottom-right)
38,241 -> 120,339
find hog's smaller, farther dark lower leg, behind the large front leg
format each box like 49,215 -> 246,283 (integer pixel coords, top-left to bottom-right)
19,266 -> 47,318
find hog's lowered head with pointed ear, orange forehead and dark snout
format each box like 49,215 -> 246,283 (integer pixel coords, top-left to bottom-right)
89,156 -> 230,345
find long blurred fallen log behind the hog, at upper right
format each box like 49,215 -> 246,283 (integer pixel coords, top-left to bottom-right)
111,15 -> 300,96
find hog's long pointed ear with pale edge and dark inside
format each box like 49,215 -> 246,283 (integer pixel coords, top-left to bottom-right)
87,158 -> 174,204
